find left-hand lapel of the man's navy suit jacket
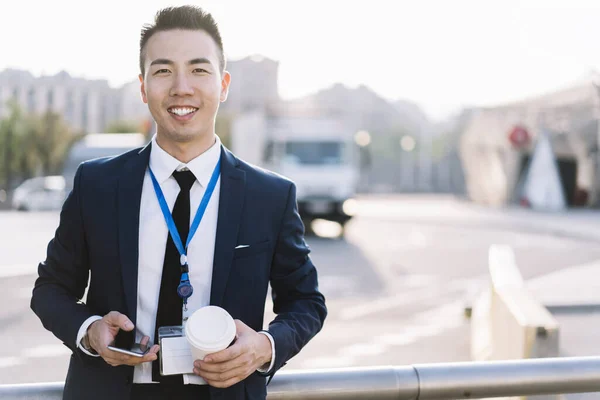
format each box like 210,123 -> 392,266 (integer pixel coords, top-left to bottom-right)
117,144 -> 151,324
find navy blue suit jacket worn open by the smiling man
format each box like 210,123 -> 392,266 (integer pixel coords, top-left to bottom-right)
31,145 -> 327,399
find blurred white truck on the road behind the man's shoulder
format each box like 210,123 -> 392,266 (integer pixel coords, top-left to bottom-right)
231,112 -> 359,233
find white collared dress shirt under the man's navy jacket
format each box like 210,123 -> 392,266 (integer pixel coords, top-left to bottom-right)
77,135 -> 275,384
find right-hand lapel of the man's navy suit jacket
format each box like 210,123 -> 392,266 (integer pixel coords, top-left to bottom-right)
210,147 -> 246,306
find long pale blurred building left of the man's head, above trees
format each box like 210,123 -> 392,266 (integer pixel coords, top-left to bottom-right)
0,69 -> 149,133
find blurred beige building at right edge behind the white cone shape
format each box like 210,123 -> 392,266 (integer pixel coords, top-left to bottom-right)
460,80 -> 600,206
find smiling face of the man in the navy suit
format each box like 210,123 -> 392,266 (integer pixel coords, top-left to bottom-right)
140,30 -> 230,143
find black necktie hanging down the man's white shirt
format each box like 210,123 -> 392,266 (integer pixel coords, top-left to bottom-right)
152,171 -> 196,384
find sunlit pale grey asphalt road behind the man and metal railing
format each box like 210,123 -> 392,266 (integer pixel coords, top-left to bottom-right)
0,197 -> 600,384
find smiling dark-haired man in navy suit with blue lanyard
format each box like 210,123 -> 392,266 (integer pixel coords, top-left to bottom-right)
31,6 -> 327,400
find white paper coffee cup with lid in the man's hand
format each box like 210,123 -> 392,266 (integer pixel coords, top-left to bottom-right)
185,306 -> 236,360
